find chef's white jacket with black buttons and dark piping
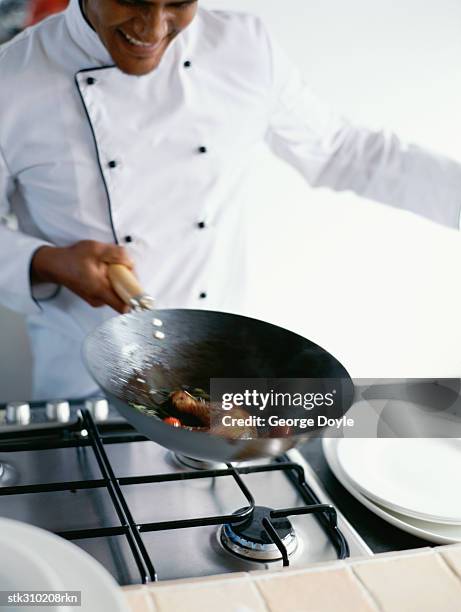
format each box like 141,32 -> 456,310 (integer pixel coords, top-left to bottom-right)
0,0 -> 461,399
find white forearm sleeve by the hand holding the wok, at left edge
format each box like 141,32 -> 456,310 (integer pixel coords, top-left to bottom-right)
0,149 -> 55,314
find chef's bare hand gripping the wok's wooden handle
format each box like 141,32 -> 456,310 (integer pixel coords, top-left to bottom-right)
31,240 -> 134,314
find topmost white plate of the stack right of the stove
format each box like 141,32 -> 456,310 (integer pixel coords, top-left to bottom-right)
337,438 -> 461,525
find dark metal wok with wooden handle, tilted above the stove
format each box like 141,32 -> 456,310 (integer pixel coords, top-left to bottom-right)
83,266 -> 354,462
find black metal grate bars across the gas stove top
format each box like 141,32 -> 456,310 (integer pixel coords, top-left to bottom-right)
0,410 -> 350,584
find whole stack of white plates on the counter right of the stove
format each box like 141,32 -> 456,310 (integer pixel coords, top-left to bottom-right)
323,438 -> 461,544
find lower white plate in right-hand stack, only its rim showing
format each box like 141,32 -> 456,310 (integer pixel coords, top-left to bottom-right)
322,438 -> 461,544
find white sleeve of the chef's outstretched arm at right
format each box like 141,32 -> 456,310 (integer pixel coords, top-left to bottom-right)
266,32 -> 461,229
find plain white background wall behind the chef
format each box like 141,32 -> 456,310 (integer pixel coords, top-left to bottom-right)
0,0 -> 461,401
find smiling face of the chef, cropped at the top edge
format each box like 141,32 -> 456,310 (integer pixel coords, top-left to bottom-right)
83,0 -> 197,76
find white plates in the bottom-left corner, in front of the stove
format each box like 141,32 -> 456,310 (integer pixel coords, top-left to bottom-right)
0,519 -> 127,612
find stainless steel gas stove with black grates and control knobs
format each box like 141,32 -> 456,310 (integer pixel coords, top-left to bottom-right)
0,398 -> 372,585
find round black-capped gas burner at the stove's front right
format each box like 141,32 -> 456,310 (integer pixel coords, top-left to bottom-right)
220,506 -> 298,562
